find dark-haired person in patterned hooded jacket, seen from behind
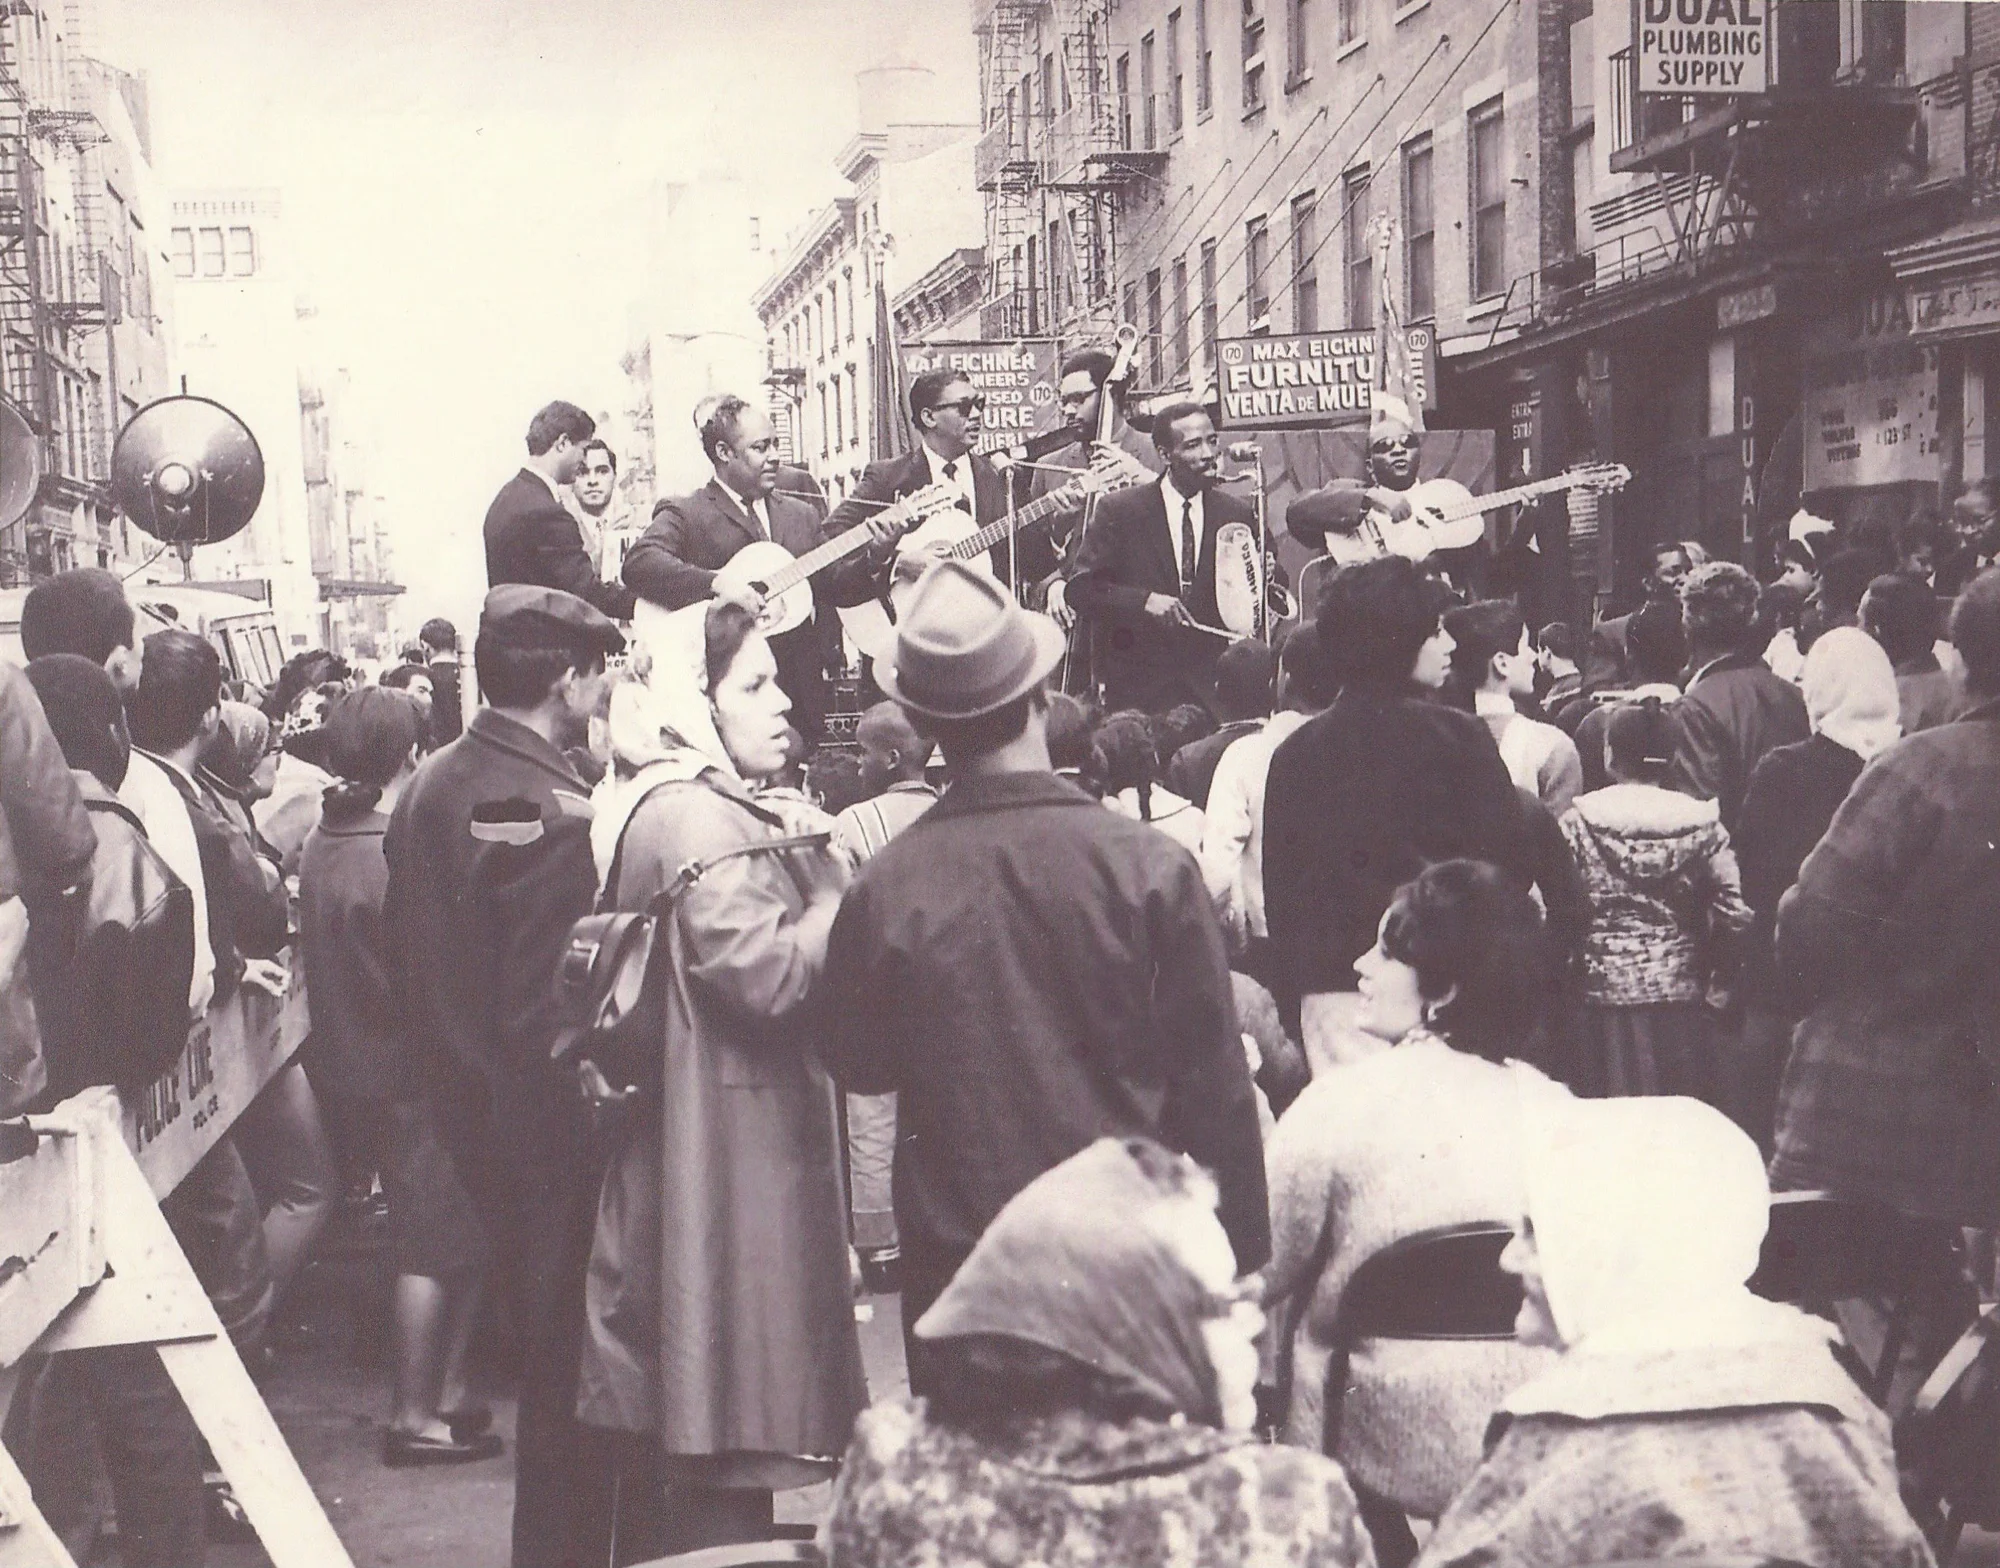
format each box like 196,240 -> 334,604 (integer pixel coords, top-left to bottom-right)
1562,698 -> 1750,1100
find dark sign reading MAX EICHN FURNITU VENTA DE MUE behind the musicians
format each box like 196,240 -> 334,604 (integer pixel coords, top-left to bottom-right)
1218,326 -> 1438,430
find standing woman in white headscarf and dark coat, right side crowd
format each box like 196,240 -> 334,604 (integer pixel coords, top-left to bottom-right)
1720,626 -> 1902,1154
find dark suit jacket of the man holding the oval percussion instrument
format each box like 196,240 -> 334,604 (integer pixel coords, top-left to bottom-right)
1070,484 -> 1256,712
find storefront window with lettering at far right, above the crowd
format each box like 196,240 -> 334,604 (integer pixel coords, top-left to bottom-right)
1804,290 -> 1940,490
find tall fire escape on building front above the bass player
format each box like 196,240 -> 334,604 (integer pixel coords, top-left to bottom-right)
974,0 -> 1166,338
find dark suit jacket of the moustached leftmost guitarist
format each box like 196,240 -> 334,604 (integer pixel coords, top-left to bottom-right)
624,480 -> 832,740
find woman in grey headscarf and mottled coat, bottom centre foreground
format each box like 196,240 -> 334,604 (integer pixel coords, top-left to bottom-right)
820,1138 -> 1370,1568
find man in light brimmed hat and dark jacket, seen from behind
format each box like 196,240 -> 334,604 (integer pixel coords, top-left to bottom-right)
822,562 -> 1270,1392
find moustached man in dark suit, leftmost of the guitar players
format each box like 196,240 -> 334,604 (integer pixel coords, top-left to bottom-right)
624,396 -> 832,744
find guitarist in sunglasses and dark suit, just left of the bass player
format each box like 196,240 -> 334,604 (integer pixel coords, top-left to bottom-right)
826,370 -> 1056,620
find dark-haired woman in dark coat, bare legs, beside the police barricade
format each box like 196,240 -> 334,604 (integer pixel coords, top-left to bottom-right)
298,686 -> 500,1466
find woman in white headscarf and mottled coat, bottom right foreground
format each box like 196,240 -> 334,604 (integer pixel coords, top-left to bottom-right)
1420,1084 -> 1932,1568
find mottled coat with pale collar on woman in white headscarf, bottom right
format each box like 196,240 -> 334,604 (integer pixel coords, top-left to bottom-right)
1418,1340 -> 1932,1568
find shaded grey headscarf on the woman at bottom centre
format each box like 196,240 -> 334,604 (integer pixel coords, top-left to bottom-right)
916,1138 -> 1222,1426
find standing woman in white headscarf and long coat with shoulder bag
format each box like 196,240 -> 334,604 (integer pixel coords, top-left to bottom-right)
578,604 -> 868,1556
